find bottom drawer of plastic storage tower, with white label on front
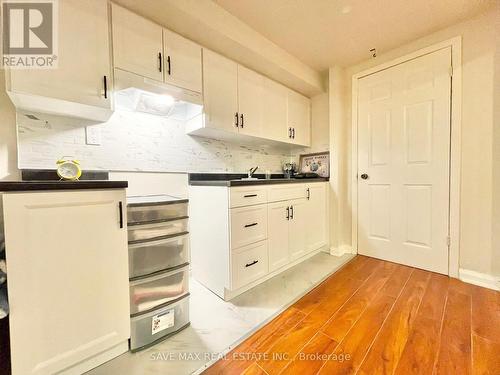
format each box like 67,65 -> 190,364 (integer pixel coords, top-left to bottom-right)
130,294 -> 189,351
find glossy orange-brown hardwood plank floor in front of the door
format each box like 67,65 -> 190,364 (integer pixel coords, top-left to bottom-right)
204,256 -> 500,375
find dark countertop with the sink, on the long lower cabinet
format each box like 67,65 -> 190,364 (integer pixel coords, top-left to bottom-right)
189,173 -> 328,187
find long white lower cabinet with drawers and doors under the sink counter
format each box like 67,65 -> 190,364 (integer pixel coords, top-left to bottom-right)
189,181 -> 327,300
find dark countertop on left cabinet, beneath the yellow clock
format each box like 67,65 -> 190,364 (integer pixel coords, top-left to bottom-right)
0,180 -> 128,192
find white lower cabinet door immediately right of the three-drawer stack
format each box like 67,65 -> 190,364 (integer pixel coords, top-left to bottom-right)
267,202 -> 290,272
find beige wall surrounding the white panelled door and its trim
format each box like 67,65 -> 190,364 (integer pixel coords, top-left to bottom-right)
330,9 -> 500,275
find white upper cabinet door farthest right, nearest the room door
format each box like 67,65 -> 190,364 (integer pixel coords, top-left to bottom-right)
287,90 -> 311,146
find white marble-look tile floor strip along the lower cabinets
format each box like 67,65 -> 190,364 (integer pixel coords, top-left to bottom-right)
88,253 -> 352,375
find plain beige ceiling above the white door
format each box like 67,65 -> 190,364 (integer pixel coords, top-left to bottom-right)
213,0 -> 497,71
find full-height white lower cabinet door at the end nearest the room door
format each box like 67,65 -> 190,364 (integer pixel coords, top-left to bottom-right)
306,182 -> 327,252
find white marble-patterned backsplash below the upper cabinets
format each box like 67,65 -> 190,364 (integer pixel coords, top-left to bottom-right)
17,110 -> 295,173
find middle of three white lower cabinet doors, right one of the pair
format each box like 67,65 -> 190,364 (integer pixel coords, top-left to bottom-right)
289,198 -> 307,261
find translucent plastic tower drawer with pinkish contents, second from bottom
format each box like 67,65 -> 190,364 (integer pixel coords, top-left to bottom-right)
130,265 -> 189,315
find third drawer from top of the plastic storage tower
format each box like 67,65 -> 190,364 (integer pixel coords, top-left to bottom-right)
128,234 -> 189,278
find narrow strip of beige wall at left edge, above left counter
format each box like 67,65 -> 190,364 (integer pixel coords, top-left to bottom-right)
0,69 -> 18,180
